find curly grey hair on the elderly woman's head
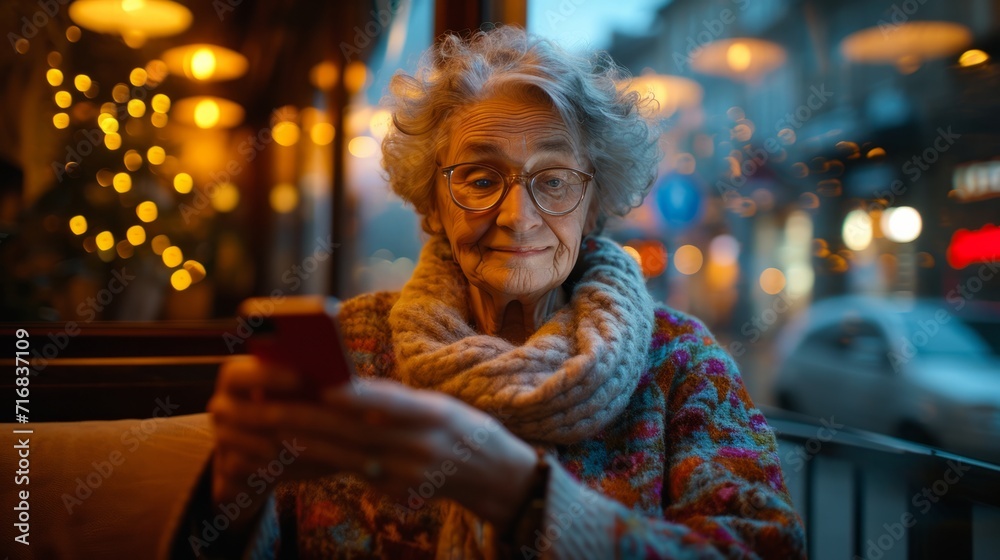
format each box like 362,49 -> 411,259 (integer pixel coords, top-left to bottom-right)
382,26 -> 661,233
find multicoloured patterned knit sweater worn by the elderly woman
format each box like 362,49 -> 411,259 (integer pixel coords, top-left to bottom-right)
219,293 -> 805,559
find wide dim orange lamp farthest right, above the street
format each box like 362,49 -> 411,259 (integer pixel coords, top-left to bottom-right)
840,21 -> 972,65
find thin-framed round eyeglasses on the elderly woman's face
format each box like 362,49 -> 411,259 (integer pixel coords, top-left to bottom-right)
441,163 -> 594,216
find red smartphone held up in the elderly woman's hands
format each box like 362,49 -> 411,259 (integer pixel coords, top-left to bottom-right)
238,296 -> 354,397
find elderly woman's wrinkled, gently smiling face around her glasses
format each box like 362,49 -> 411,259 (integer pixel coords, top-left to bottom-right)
431,97 -> 593,302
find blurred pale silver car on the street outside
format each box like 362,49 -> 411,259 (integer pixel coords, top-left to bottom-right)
775,296 -> 1000,463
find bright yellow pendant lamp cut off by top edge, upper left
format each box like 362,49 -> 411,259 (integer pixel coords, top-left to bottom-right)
69,0 -> 192,38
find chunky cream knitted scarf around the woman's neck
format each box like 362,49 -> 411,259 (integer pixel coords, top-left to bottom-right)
389,235 -> 653,444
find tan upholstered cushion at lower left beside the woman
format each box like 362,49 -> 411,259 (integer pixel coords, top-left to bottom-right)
0,414 -> 213,559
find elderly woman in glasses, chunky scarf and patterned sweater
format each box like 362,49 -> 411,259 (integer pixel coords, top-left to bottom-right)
173,27 -> 804,558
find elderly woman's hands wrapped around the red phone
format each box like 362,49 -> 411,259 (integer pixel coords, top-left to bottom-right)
210,357 -> 537,531
